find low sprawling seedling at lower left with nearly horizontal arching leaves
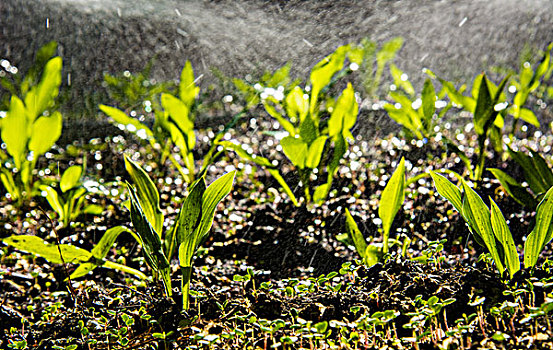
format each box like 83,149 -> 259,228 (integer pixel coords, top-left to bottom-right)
2,226 -> 147,279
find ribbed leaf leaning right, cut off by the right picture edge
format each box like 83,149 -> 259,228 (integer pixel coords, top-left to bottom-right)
524,187 -> 553,268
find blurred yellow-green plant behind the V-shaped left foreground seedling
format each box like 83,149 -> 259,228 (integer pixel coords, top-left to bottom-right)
100,61 -> 201,183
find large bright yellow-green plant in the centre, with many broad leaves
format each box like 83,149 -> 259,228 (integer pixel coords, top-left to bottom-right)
220,45 -> 360,205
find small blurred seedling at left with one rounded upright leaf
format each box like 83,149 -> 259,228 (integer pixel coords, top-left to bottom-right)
40,158 -> 102,227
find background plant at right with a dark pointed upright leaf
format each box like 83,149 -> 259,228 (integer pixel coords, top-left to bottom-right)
426,70 -> 509,181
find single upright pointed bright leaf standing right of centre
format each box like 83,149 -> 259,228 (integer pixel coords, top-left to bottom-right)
378,157 -> 405,254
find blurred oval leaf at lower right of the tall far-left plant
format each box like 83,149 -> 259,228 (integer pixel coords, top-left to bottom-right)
29,111 -> 63,157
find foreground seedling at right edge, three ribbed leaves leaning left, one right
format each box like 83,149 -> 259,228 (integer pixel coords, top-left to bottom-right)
431,172 -> 553,278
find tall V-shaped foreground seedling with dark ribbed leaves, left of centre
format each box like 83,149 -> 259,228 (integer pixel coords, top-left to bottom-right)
121,157 -> 235,310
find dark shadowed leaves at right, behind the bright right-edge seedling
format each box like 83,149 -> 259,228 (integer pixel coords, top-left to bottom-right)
488,146 -> 553,209
